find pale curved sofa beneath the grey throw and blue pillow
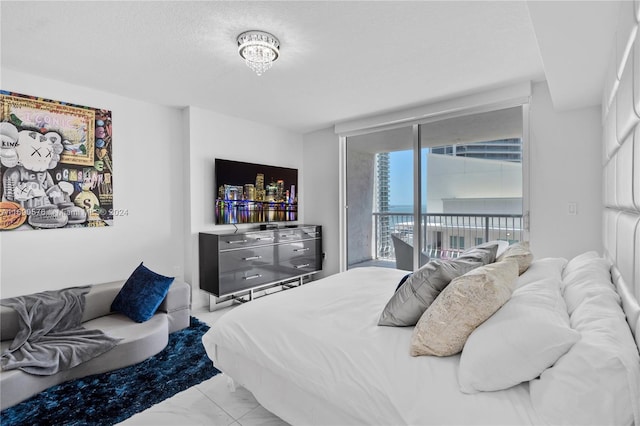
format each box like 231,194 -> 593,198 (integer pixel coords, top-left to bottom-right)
0,280 -> 191,410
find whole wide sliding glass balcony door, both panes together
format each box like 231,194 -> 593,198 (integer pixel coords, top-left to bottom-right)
346,106 -> 526,270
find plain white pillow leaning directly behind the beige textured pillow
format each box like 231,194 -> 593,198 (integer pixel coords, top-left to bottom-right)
458,271 -> 580,393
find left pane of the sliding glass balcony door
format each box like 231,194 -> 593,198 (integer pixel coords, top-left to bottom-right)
346,127 -> 414,268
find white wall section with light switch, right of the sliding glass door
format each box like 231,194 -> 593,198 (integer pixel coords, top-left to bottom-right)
529,83 -> 602,258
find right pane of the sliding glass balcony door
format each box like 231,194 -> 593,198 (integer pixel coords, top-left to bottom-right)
420,107 -> 524,258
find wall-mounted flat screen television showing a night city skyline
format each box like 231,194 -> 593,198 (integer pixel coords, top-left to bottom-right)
215,158 -> 299,225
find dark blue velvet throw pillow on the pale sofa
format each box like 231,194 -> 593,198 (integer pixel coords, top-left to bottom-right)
111,263 -> 173,322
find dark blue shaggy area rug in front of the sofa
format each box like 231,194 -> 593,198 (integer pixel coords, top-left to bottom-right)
0,317 -> 220,426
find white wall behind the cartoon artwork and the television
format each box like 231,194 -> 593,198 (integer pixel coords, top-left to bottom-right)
0,69 -> 306,303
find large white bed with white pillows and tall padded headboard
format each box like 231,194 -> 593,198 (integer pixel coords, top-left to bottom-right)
203,10 -> 640,426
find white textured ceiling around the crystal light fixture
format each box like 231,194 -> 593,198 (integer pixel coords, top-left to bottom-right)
0,0 -> 620,133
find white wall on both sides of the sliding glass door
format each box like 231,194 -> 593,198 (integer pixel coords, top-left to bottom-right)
304,83 -> 602,273
